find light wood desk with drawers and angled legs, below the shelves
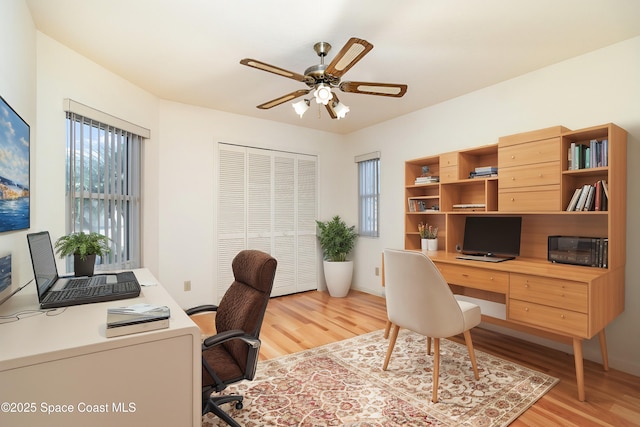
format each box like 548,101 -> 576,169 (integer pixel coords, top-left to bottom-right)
428,252 -> 624,401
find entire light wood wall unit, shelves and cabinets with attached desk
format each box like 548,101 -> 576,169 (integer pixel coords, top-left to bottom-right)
405,124 -> 627,400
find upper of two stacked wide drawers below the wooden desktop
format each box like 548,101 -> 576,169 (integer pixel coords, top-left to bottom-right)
509,273 -> 588,313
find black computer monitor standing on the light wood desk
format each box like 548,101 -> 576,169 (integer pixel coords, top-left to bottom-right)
462,215 -> 522,260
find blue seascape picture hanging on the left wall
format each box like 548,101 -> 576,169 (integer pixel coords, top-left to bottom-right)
0,96 -> 31,233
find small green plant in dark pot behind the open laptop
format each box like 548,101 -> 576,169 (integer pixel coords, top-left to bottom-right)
55,231 -> 111,276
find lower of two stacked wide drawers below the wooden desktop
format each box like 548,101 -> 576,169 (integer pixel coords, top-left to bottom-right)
507,299 -> 588,338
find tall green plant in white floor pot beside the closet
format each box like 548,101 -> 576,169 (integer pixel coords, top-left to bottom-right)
316,215 -> 358,297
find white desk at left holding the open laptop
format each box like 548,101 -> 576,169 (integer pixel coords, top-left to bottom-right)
0,269 -> 201,427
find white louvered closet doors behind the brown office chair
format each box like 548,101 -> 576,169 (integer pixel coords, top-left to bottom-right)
217,144 -> 318,299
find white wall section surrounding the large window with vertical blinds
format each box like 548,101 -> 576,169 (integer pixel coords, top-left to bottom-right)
33,32 -> 159,278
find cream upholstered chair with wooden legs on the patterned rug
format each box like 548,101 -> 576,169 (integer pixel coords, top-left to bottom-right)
382,249 -> 480,403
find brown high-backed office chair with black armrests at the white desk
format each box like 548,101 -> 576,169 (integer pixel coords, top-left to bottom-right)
187,250 -> 277,427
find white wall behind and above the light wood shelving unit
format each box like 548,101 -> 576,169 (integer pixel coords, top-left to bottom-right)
345,38 -> 640,375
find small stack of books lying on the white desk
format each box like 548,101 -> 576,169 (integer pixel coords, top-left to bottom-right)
106,304 -> 171,338
